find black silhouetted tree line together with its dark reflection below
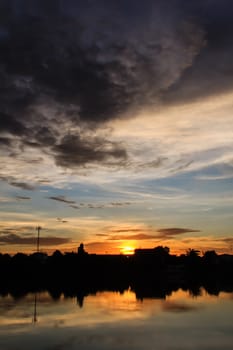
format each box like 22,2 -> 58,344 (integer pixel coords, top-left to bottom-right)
0,244 -> 233,305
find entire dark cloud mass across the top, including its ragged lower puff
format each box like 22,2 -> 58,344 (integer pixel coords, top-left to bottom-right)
0,0 -> 233,168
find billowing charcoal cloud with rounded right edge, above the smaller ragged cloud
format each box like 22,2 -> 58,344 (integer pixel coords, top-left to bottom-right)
0,1 -> 195,122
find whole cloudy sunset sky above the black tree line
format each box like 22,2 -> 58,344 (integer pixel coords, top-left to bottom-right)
0,0 -> 233,254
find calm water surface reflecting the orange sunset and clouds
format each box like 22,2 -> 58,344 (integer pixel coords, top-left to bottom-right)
0,290 -> 233,350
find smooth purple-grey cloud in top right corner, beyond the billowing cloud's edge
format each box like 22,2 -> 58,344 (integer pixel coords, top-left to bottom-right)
165,0 -> 233,103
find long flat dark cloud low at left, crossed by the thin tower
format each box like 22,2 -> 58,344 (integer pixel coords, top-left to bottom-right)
0,233 -> 70,246
